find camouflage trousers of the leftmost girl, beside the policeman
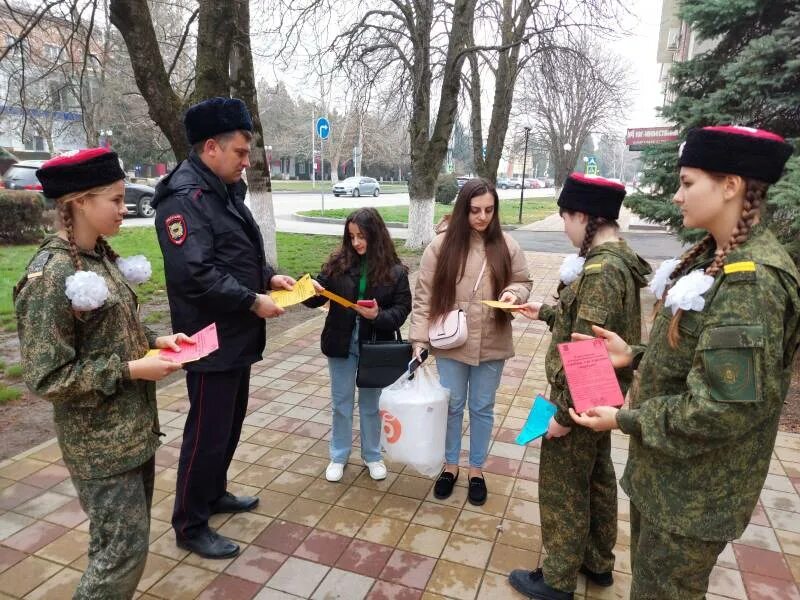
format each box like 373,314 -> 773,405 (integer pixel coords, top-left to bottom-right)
72,458 -> 155,600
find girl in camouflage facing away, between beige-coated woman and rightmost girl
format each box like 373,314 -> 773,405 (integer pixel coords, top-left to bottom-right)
509,173 -> 650,600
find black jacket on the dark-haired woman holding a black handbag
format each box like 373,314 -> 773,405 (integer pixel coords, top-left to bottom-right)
304,265 -> 411,358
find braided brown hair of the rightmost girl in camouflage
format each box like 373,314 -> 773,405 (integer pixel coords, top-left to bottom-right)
657,172 -> 769,348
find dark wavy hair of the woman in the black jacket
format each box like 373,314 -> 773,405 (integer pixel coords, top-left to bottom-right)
322,206 -> 408,285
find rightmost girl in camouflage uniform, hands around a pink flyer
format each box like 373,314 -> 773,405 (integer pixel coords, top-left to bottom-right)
573,127 -> 800,600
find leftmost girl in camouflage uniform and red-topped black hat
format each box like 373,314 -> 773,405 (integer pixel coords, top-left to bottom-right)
14,148 -> 185,600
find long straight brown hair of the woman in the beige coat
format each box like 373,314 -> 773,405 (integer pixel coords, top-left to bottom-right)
430,178 -> 511,321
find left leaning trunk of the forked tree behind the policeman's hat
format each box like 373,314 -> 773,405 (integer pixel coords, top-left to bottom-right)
110,0 -> 187,159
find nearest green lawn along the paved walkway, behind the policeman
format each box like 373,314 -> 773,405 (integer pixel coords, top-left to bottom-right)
0,227 -> 420,331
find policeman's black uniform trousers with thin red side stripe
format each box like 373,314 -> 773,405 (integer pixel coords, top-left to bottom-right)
172,366 -> 250,539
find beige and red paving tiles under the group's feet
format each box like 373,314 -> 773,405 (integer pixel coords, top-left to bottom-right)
0,253 -> 800,600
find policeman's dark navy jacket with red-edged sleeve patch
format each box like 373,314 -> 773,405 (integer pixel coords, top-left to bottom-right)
152,152 -> 275,372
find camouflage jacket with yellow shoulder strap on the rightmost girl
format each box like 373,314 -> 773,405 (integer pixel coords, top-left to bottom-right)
617,225 -> 800,541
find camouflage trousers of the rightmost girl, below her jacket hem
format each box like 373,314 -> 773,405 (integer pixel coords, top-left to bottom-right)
631,503 -> 726,600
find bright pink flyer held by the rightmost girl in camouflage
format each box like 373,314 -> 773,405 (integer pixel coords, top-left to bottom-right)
558,338 -> 625,413
